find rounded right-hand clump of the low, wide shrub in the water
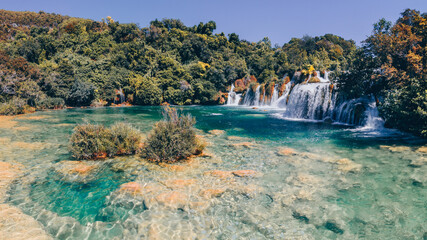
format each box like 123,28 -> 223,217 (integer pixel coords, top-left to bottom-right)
110,122 -> 142,155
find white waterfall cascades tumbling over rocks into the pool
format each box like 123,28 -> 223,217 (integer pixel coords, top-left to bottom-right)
227,72 -> 384,129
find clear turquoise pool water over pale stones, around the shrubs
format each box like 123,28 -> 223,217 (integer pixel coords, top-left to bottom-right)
0,106 -> 427,239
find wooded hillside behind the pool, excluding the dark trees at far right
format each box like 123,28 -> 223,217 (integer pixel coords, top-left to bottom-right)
0,10 -> 356,108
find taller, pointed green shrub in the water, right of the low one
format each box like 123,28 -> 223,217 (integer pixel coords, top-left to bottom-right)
142,106 -> 204,162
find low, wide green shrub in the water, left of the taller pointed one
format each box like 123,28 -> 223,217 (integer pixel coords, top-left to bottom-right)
69,123 -> 142,159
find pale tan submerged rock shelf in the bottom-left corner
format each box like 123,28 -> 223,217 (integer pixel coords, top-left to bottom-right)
0,204 -> 52,240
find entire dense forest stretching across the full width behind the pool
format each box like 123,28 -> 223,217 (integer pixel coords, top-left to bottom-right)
0,9 -> 427,136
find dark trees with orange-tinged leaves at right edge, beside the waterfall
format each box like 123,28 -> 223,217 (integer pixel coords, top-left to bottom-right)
338,9 -> 427,136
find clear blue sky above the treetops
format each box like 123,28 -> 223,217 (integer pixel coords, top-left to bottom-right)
0,0 -> 427,45
